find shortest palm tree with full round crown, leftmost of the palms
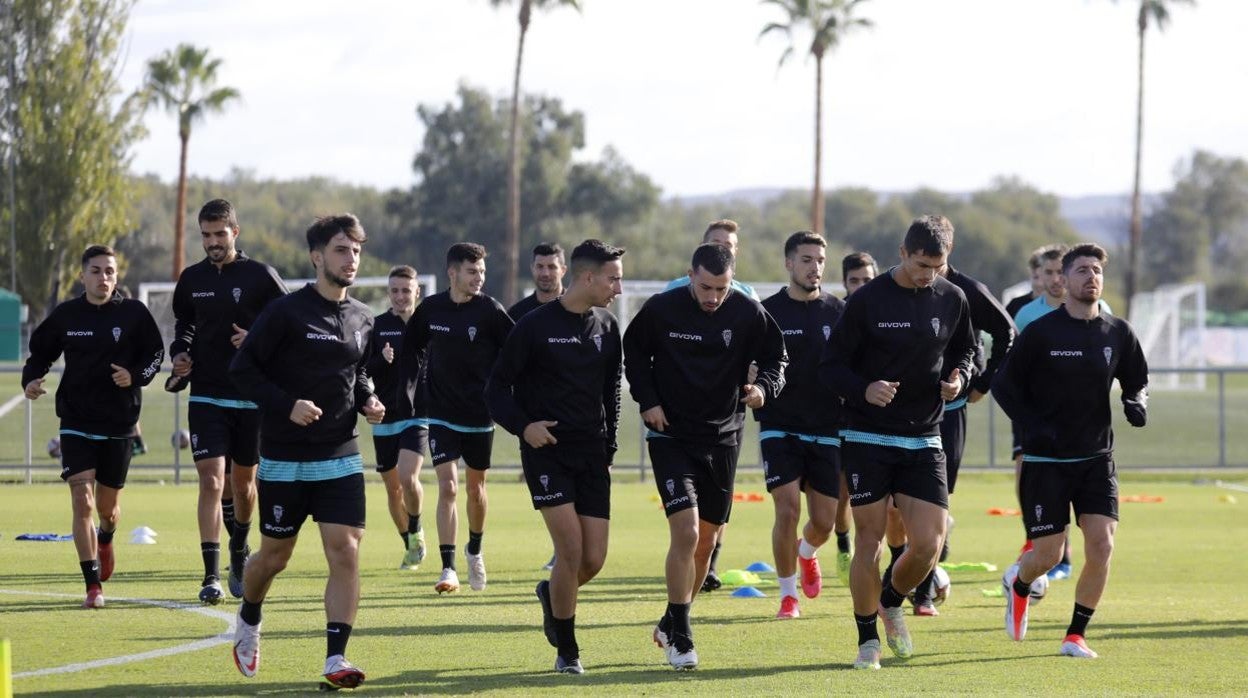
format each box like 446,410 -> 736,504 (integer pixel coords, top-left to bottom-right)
147,44 -> 240,281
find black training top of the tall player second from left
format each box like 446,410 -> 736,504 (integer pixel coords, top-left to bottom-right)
168,250 -> 286,400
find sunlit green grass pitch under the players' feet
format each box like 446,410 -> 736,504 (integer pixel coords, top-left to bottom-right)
0,473 -> 1248,696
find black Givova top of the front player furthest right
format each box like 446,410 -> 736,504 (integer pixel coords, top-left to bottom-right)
992,306 -> 1148,458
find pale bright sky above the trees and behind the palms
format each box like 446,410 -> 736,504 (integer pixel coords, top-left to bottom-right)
121,0 -> 1248,196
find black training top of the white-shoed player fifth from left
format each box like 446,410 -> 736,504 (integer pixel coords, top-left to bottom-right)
399,291 -> 514,427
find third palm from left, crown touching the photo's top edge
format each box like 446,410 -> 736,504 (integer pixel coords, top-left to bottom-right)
759,0 -> 872,233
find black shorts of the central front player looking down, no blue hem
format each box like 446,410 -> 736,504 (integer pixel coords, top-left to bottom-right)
646,437 -> 738,526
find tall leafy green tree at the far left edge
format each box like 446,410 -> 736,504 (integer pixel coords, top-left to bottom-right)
0,0 -> 142,317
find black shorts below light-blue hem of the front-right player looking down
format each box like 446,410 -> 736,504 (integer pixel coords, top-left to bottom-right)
841,436 -> 948,509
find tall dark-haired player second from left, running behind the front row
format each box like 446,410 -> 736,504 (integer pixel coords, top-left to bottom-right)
168,199 -> 286,604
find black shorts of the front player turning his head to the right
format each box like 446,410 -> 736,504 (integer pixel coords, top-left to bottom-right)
520,445 -> 612,518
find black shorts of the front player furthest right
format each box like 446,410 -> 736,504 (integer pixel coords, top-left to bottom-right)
1018,456 -> 1118,539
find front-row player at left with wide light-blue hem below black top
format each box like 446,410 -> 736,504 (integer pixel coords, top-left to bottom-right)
230,214 -> 386,688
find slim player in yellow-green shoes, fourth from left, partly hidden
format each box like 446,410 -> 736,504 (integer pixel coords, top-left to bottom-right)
368,265 -> 429,571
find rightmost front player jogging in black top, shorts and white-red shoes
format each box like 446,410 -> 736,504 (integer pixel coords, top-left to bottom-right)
992,243 -> 1148,658
